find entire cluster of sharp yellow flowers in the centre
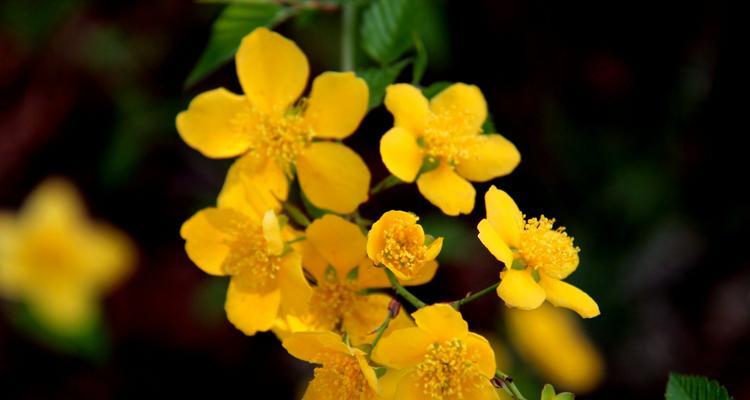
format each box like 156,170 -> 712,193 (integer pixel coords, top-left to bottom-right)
176,28 -> 599,400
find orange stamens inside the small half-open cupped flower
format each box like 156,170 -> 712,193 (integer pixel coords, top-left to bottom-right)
382,220 -> 425,276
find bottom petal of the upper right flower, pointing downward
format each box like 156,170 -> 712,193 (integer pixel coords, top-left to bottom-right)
417,163 -> 476,216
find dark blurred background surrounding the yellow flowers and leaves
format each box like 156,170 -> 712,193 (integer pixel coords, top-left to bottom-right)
0,0 -> 750,399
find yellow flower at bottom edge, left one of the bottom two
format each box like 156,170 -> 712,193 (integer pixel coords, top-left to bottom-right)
283,332 -> 378,400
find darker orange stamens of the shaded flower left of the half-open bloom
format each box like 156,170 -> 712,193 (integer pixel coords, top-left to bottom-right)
310,281 -> 357,331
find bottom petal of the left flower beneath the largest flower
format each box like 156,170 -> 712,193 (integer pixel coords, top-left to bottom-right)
224,279 -> 281,336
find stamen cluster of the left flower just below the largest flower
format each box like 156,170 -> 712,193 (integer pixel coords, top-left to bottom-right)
222,221 -> 281,291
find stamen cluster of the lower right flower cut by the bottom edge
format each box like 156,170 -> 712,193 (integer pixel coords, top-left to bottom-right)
416,339 -> 484,400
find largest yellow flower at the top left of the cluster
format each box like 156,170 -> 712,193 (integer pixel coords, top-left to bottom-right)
177,28 -> 370,213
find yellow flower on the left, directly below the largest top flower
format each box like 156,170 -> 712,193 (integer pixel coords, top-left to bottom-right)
180,188 -> 312,335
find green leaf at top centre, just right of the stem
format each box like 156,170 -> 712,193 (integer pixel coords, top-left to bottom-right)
361,0 -> 417,65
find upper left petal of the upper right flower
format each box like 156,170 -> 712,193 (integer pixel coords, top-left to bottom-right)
384,83 -> 430,134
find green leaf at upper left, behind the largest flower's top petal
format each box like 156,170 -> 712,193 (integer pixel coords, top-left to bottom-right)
185,2 -> 292,86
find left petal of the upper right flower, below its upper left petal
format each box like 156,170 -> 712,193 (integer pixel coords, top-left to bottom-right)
380,127 -> 424,182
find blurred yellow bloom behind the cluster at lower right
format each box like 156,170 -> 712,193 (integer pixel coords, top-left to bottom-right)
505,305 -> 604,393
